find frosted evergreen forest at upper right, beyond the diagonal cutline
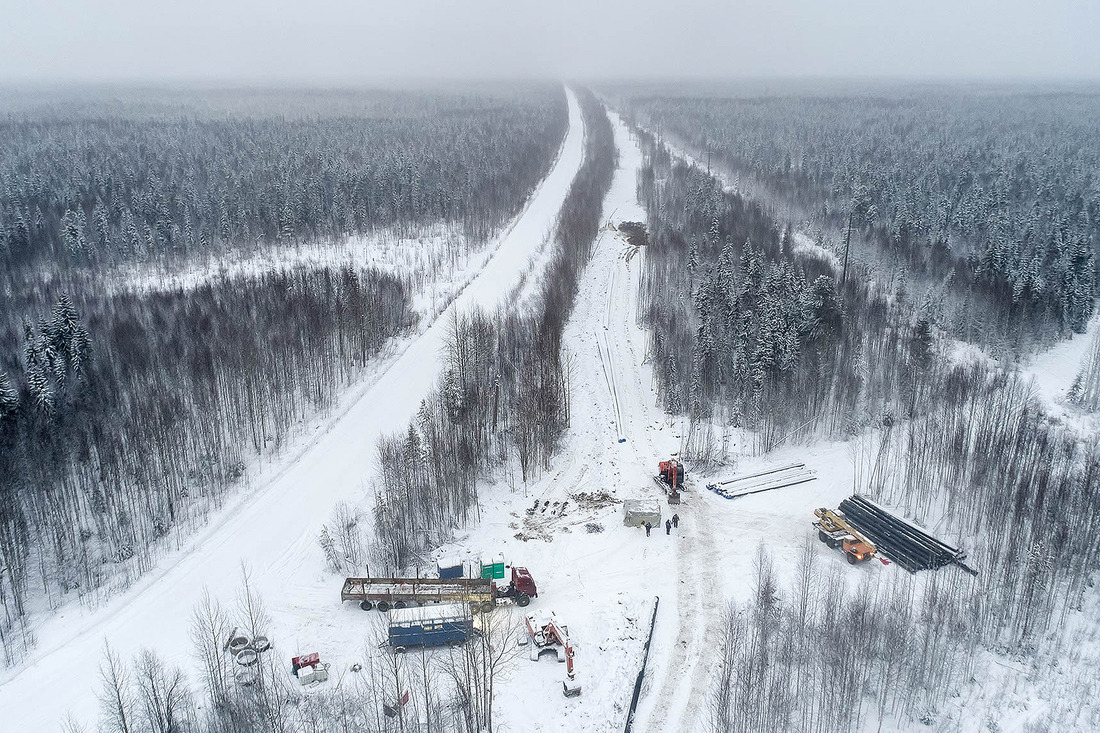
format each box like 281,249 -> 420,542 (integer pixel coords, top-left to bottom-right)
624,89 -> 1100,348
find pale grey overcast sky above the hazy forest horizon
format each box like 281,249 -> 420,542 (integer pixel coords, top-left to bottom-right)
0,0 -> 1100,83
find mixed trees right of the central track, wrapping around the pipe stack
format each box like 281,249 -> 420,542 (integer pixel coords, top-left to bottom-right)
624,101 -> 1100,731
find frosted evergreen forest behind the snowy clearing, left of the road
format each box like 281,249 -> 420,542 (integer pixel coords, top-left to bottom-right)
0,85 -> 568,270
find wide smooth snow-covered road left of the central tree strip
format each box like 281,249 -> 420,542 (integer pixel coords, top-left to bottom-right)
0,84 -> 584,732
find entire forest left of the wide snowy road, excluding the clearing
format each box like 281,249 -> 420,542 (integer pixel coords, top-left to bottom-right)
0,86 -> 565,664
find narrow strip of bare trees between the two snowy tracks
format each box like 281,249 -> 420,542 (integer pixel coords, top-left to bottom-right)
365,90 -> 617,572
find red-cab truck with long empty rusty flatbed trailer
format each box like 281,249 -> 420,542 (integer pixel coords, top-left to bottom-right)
340,567 -> 538,611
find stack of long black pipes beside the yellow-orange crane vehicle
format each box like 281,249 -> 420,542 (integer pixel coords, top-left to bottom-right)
840,495 -> 978,575
